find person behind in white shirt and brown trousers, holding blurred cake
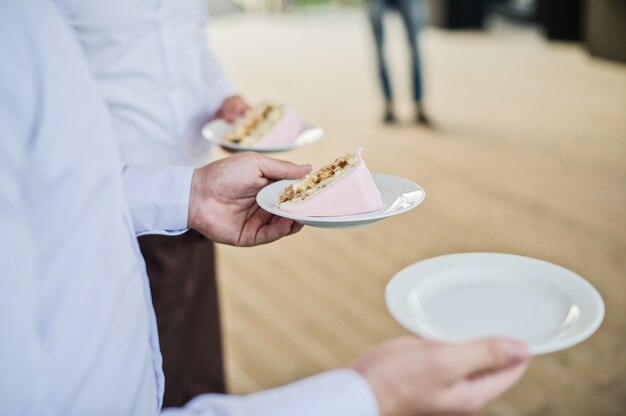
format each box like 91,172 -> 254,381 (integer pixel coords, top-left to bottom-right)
62,0 -> 248,406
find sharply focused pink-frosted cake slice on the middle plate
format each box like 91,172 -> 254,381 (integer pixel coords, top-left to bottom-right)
278,149 -> 383,217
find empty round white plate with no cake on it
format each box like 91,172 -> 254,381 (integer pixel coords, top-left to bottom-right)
385,253 -> 604,355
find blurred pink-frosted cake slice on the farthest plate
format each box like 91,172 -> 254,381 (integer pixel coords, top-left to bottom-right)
224,102 -> 302,147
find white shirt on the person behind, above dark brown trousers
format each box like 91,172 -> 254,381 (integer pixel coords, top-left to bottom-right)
61,0 -> 235,167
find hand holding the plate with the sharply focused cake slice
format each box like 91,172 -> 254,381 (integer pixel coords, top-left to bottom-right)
189,153 -> 311,246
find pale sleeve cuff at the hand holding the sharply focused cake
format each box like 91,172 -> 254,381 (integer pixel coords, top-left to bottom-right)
122,165 -> 194,235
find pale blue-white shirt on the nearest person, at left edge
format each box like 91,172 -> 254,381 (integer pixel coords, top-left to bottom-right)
0,0 -> 377,416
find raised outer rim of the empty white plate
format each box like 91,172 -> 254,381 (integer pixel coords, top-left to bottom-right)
385,251 -> 606,355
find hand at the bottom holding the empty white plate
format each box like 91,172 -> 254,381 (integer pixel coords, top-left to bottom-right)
350,337 -> 530,416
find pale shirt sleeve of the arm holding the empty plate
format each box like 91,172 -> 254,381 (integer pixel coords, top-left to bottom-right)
161,369 -> 379,416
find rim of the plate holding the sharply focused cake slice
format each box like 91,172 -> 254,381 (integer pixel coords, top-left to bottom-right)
256,172 -> 426,228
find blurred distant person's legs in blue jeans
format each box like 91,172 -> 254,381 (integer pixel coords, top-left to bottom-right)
367,0 -> 431,126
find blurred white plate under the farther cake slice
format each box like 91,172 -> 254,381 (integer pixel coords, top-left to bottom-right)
202,119 -> 324,153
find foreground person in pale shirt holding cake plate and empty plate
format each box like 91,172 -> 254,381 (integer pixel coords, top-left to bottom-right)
0,0 -> 528,416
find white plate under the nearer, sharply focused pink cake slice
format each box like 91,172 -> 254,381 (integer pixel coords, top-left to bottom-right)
256,173 -> 426,228
